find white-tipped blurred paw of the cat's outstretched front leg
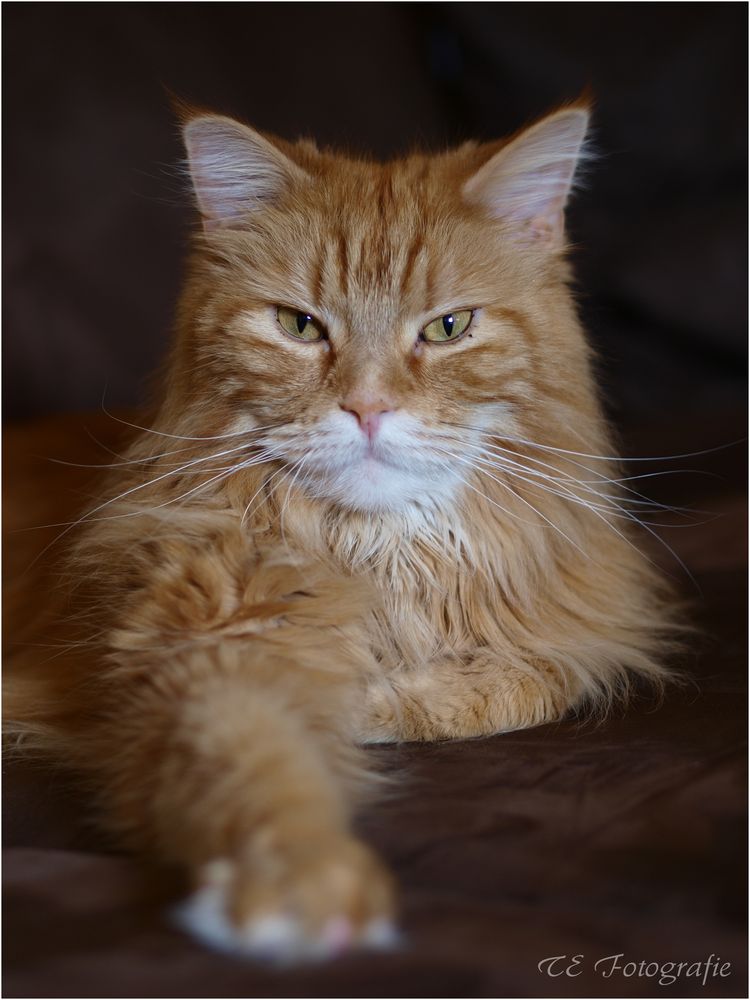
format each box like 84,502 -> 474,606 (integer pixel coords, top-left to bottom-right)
175,838 -> 397,963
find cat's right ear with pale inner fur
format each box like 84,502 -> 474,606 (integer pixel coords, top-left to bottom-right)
463,106 -> 589,248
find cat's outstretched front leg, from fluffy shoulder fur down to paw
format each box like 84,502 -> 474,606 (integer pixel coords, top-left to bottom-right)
73,554 -> 393,960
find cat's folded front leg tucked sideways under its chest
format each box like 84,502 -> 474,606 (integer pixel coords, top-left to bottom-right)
359,650 -> 578,743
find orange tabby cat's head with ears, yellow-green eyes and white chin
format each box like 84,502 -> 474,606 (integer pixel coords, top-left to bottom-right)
178,106 -> 590,510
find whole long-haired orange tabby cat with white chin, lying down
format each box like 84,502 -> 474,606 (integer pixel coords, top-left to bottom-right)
8,102 -> 673,960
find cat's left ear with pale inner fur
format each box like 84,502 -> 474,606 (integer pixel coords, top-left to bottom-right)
182,114 -> 307,229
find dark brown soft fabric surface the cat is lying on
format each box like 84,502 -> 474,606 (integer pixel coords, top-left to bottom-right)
3,417 -> 747,997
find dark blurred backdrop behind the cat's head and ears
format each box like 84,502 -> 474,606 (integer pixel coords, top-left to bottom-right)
3,3 -> 747,436
